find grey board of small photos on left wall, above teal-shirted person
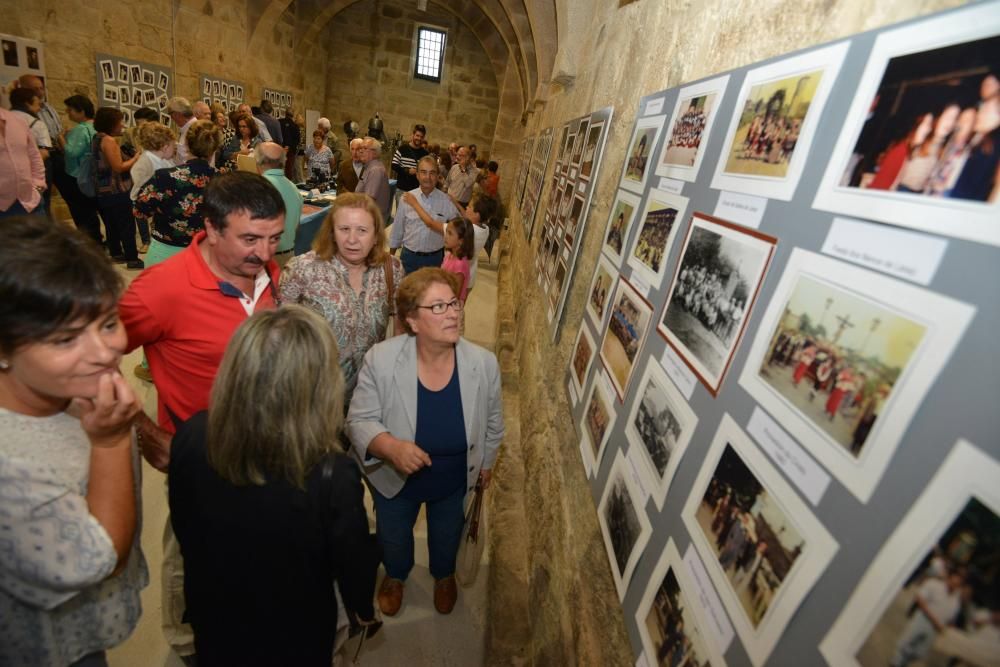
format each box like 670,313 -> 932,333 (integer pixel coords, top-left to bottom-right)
96,53 -> 174,127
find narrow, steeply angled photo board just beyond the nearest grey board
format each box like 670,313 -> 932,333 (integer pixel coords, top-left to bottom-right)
535,107 -> 614,341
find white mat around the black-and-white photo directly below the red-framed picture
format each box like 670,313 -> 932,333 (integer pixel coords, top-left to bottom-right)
625,357 -> 698,510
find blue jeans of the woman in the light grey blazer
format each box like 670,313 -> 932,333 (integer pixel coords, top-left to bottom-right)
371,485 -> 465,581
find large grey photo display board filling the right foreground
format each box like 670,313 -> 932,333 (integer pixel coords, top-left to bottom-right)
560,1 -> 1000,667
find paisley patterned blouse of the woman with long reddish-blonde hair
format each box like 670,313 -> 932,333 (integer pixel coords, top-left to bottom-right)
281,250 -> 403,404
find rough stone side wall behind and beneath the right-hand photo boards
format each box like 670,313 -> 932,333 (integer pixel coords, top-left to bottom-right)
488,0 -> 961,665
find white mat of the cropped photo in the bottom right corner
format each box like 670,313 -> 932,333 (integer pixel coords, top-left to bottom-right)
819,439 -> 1000,667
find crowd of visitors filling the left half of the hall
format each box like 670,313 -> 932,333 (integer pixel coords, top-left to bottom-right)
0,77 -> 504,666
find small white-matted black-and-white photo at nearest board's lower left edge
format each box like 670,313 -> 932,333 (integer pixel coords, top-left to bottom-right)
597,449 -> 653,600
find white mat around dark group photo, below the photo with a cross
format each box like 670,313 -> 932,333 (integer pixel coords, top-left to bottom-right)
681,413 -> 838,667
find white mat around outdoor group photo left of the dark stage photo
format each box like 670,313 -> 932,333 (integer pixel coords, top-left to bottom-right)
712,41 -> 850,201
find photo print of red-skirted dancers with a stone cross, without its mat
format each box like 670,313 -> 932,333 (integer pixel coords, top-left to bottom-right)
759,275 -> 927,458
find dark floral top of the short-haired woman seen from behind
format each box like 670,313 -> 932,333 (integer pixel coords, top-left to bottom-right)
133,158 -> 216,248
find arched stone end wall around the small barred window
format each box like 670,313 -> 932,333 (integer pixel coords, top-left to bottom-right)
324,0 -> 499,155
